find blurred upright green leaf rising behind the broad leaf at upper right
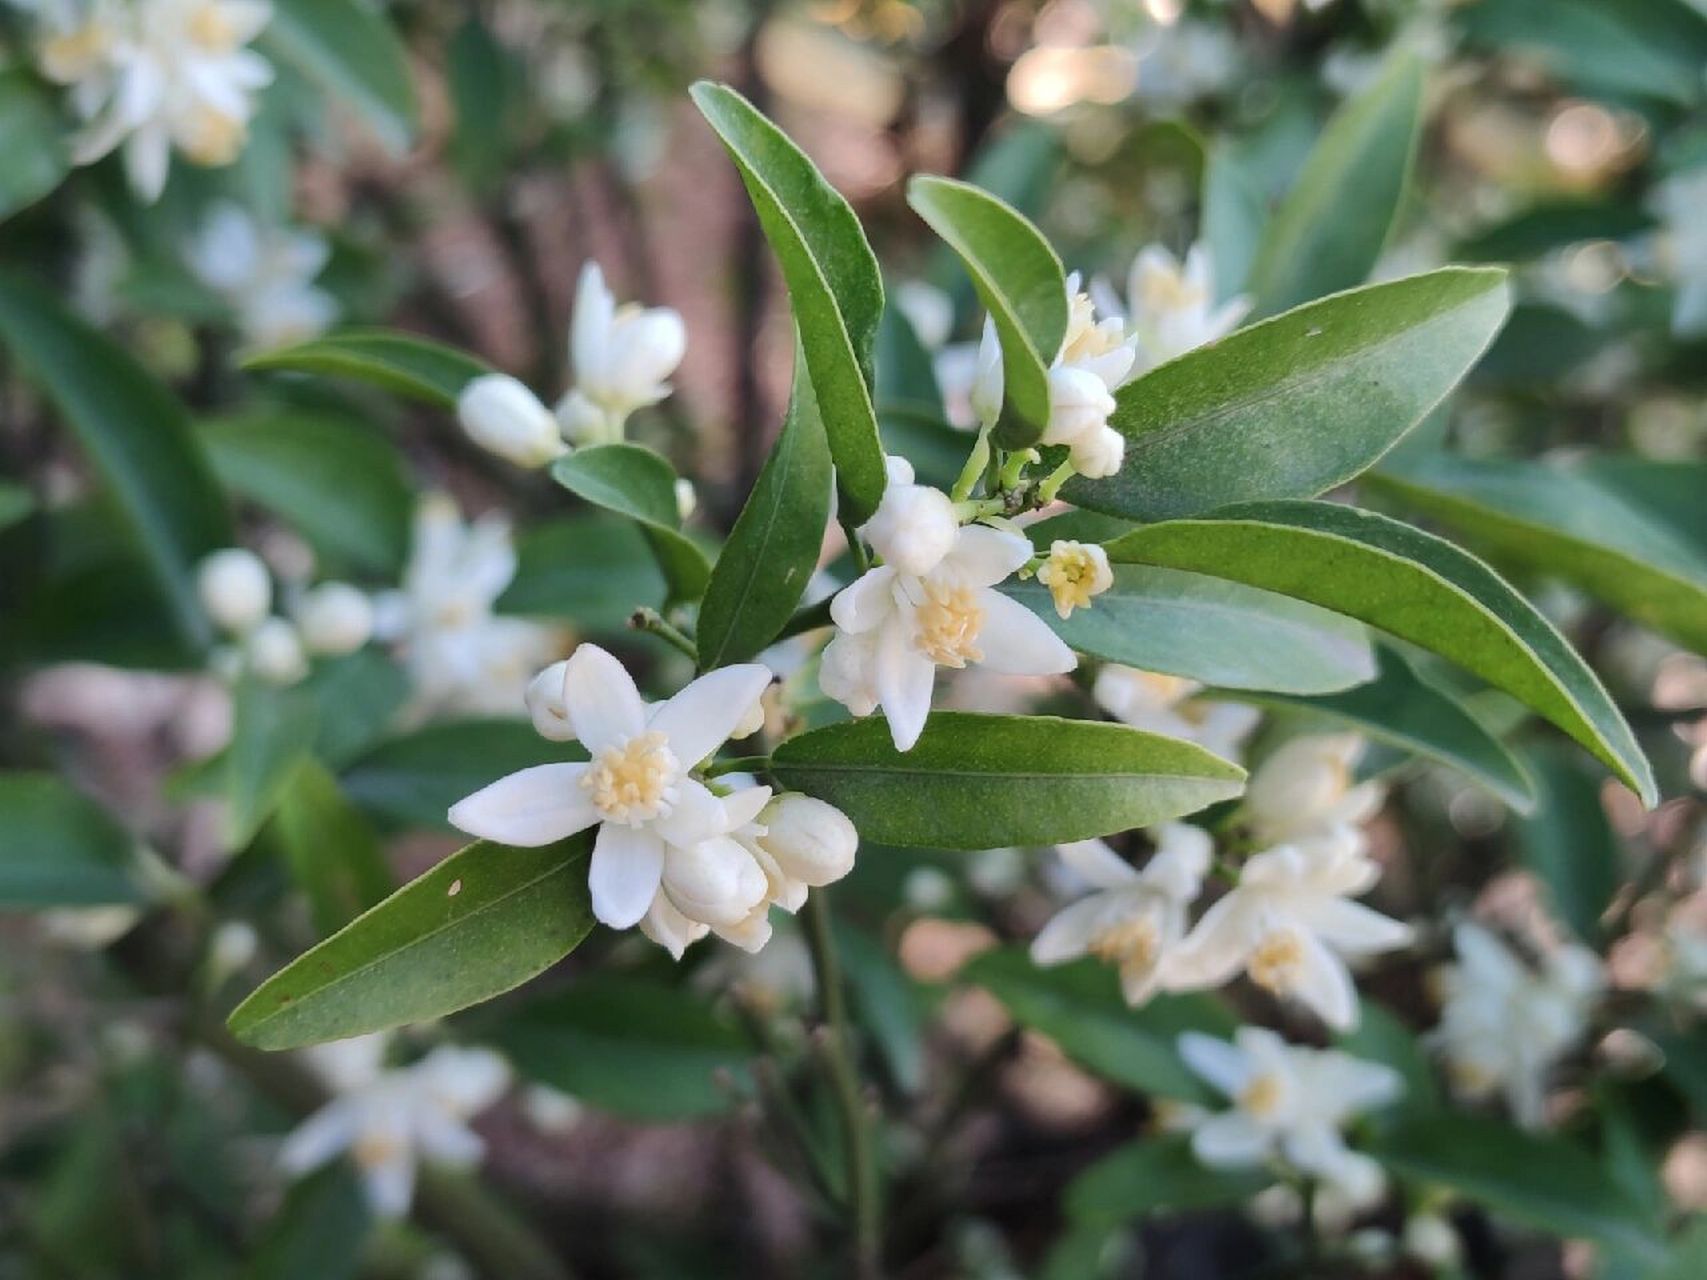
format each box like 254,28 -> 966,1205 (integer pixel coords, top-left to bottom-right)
1248,55 -> 1422,316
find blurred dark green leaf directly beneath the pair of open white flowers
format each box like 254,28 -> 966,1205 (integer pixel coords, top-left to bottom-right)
959,947 -> 1234,1103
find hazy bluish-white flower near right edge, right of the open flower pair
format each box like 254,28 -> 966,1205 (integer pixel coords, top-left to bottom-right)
1432,922 -> 1605,1128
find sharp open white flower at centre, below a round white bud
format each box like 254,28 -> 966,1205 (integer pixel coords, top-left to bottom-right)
818,512 -> 1077,751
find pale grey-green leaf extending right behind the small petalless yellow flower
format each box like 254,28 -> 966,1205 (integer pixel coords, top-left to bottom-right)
1002,566 -> 1376,693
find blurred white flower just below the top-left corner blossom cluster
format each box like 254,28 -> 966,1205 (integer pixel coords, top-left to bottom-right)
184,200 -> 338,346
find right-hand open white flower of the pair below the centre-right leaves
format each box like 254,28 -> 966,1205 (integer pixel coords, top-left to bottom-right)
1168,828 -> 1412,1031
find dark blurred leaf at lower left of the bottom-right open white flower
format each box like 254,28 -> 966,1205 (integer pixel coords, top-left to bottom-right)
1063,1135 -> 1273,1224
